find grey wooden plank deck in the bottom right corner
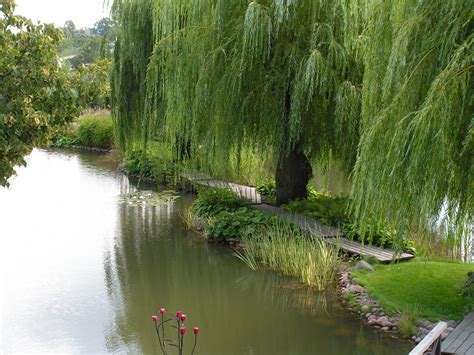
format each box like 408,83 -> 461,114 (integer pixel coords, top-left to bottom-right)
441,311 -> 474,355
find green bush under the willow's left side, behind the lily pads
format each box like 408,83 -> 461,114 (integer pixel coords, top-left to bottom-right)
124,149 -> 177,185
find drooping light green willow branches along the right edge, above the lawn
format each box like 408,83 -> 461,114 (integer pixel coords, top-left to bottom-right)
352,0 -> 474,258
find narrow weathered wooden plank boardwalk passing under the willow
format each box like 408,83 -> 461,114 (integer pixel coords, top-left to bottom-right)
182,173 -> 414,263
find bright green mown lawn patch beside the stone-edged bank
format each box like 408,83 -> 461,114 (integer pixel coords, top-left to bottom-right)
352,260 -> 474,321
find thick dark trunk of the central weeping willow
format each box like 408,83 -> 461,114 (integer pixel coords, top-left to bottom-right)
275,147 -> 313,206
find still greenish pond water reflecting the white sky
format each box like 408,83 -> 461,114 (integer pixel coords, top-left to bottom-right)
0,150 -> 409,355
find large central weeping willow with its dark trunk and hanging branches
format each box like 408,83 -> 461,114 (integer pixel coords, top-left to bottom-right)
112,0 -> 365,204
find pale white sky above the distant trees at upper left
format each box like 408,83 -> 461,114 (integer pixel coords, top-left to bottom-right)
15,0 -> 108,28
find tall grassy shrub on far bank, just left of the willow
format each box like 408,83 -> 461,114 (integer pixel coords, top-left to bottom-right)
76,115 -> 114,149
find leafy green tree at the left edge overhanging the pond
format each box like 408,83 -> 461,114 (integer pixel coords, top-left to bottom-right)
0,0 -> 77,185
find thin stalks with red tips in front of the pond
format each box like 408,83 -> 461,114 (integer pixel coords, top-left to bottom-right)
151,308 -> 199,355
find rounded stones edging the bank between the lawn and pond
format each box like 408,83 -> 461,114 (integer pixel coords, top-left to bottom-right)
338,271 -> 458,343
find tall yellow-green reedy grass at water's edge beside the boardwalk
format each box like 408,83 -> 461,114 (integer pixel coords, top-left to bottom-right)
241,219 -> 339,291
